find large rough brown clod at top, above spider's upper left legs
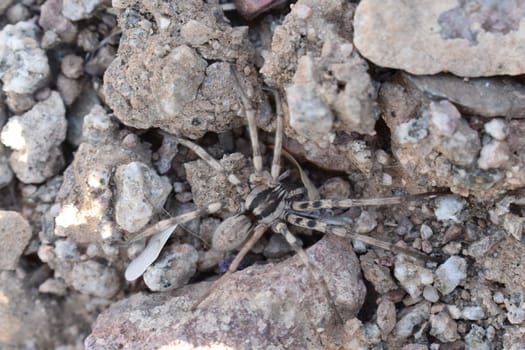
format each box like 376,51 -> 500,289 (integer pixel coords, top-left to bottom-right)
104,0 -> 270,138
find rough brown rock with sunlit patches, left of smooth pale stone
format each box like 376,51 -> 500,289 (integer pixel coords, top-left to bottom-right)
55,106 -> 150,243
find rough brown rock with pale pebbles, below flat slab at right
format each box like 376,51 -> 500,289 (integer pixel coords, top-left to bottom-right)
379,75 -> 525,198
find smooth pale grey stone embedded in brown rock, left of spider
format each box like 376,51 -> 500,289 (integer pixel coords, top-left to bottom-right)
115,162 -> 171,233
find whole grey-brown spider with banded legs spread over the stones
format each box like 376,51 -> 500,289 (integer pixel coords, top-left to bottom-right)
122,68 -> 433,315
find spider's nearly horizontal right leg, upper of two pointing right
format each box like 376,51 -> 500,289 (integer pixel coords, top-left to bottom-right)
291,193 -> 438,211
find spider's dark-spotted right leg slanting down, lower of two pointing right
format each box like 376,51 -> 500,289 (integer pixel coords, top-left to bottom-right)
286,214 -> 436,261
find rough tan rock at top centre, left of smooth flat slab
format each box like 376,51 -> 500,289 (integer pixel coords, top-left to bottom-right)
261,0 -> 378,172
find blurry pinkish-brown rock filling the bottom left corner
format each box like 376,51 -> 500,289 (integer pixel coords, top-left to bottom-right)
0,272 -> 61,349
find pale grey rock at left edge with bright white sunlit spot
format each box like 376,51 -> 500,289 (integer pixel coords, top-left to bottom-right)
0,92 -> 67,183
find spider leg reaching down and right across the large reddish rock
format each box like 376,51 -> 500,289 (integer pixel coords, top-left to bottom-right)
272,222 -> 344,324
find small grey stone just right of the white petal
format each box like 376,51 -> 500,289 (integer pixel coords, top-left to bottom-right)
143,244 -> 199,292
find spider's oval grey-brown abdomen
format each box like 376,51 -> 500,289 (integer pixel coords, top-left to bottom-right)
212,214 -> 252,252
